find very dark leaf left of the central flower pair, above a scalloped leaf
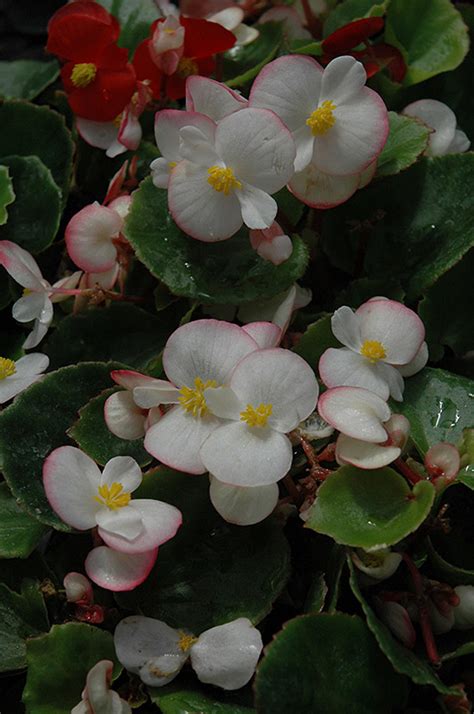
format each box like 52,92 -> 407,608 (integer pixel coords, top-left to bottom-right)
44,303 -> 170,368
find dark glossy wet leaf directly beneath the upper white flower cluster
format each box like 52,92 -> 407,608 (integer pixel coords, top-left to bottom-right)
125,178 -> 308,304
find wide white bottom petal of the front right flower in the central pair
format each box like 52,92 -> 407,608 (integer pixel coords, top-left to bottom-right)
201,422 -> 293,486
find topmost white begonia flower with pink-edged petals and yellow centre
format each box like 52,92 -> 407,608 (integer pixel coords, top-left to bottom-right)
249,55 -> 389,176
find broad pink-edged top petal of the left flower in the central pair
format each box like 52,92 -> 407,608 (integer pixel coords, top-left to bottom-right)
163,320 -> 258,388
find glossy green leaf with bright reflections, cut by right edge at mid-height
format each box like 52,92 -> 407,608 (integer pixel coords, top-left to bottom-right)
397,367 -> 474,454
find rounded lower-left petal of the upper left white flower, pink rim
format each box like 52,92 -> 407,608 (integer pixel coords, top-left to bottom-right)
168,161 -> 243,243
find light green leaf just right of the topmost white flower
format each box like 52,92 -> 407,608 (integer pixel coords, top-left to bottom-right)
377,112 -> 431,176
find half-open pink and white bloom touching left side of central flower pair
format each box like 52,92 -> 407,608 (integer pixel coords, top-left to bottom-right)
104,369 -> 170,440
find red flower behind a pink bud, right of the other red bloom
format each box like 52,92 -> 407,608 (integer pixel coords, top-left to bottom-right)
133,17 -> 235,99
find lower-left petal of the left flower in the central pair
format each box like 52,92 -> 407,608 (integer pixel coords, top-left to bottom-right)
145,406 -> 220,474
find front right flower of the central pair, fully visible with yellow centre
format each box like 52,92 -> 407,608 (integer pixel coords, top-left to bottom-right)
201,348 -> 318,486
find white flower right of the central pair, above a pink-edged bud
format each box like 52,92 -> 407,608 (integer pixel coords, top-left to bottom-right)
319,299 -> 425,401
